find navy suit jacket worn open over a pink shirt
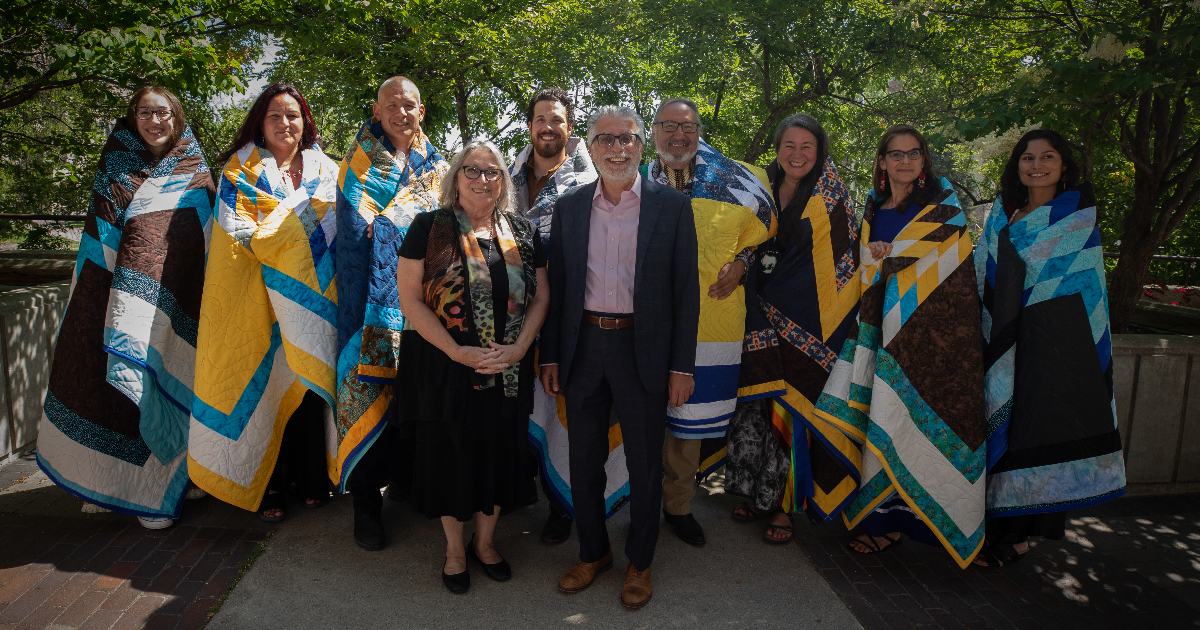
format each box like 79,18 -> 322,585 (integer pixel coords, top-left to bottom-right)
539,178 -> 700,391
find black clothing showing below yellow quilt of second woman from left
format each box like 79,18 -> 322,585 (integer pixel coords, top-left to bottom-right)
266,391 -> 329,500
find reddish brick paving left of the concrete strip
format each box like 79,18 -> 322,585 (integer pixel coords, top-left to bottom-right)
0,457 -> 272,630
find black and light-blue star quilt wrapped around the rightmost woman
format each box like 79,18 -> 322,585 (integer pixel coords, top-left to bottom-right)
976,185 -> 1126,517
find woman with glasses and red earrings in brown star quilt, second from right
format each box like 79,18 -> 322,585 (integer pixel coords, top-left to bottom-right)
815,125 -> 986,566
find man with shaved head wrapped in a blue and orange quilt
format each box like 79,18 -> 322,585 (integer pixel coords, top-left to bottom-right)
330,76 -> 450,551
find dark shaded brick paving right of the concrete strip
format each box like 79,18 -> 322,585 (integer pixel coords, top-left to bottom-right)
796,494 -> 1200,630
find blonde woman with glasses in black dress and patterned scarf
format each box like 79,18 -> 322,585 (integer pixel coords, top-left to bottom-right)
396,140 -> 548,593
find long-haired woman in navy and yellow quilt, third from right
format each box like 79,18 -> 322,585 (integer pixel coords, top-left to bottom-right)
725,114 -> 858,544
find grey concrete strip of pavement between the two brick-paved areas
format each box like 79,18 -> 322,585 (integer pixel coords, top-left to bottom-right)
208,477 -> 862,630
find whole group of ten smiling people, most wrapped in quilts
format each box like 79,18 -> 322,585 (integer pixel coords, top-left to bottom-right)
37,76 -> 1124,608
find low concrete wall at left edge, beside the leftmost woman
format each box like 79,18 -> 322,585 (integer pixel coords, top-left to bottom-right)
0,280 -> 71,462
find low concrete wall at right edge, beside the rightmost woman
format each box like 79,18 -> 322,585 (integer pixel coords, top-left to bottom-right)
1112,335 -> 1200,494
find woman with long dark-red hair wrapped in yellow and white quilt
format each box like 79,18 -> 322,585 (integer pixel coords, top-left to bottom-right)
191,83 -> 337,522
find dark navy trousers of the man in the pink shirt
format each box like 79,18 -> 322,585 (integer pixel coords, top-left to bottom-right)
565,324 -> 667,571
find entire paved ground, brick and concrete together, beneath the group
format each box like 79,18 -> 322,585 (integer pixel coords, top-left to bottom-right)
0,444 -> 1200,630
